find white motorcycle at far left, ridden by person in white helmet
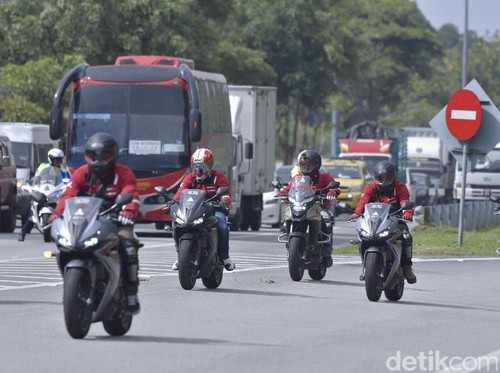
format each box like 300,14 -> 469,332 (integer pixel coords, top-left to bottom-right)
21,167 -> 69,242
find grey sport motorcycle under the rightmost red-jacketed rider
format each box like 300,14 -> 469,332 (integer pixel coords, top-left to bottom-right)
339,201 -> 414,302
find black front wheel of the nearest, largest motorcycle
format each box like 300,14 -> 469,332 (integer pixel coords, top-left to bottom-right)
63,268 -> 92,339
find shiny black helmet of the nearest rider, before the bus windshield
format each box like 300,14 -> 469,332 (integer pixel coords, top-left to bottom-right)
85,132 -> 118,176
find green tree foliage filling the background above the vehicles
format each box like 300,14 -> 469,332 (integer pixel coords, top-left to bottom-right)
0,0 -> 500,162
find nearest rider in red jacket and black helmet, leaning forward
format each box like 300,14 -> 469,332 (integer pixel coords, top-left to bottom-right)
49,132 -> 140,315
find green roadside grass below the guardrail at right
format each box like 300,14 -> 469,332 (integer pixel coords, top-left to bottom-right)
333,225 -> 500,256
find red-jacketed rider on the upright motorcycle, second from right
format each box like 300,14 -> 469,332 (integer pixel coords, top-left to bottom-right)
275,150 -> 341,268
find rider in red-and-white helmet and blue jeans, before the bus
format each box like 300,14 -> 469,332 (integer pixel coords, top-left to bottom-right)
172,148 -> 235,271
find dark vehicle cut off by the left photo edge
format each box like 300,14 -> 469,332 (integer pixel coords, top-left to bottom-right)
0,136 -> 17,233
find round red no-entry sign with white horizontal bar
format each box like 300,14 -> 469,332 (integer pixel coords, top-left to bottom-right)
446,89 -> 483,141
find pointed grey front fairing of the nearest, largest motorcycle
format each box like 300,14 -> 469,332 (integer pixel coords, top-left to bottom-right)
63,197 -> 102,246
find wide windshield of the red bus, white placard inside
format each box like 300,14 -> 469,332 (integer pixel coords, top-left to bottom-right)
67,84 -> 190,177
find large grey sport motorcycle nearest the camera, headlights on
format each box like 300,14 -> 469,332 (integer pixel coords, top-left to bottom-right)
39,193 -> 136,339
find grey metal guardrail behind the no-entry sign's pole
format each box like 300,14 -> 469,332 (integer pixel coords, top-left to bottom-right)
424,201 -> 500,231
